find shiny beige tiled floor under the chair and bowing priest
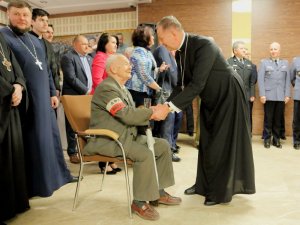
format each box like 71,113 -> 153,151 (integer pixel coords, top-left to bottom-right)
8,134 -> 300,225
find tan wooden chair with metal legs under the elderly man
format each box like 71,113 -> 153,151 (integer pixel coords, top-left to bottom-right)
61,95 -> 132,218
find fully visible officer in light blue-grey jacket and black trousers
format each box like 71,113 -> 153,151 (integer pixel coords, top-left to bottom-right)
258,42 -> 290,148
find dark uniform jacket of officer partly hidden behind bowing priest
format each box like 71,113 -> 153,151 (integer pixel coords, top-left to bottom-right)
227,56 -> 257,100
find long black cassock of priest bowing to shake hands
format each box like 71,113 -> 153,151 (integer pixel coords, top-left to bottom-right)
170,34 -> 255,203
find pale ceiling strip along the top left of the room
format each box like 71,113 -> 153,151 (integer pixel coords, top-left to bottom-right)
0,0 -> 152,14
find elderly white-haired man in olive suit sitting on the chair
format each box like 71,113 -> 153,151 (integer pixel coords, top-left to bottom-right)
84,54 -> 181,220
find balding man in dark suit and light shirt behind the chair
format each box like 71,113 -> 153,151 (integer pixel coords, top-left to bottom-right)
61,35 -> 92,163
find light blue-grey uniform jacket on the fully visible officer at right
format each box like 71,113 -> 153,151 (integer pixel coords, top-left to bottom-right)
258,59 -> 290,101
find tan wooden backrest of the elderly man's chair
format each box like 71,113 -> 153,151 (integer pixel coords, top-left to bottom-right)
61,95 -> 93,133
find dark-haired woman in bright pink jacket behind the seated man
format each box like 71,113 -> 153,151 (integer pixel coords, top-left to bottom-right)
91,33 -> 121,175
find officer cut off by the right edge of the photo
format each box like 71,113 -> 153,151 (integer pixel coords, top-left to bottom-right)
290,56 -> 300,150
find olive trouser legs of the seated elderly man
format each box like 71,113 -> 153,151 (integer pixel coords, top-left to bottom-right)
126,135 -> 175,201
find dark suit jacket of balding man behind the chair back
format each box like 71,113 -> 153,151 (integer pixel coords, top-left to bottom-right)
60,50 -> 92,95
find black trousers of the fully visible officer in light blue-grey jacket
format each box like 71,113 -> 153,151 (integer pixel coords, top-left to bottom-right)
264,101 -> 285,141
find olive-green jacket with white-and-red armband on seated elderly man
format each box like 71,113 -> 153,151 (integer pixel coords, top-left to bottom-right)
84,77 -> 152,156
